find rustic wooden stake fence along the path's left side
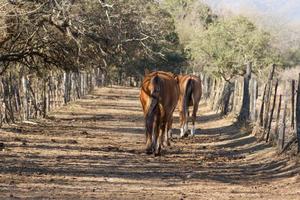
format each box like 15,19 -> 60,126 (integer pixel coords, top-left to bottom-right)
0,69 -> 104,127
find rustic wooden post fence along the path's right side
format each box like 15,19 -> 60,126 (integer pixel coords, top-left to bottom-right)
202,65 -> 300,152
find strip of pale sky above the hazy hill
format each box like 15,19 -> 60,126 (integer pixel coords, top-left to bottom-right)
203,0 -> 300,24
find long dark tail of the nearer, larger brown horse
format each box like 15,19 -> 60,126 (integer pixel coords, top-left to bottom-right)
145,75 -> 160,138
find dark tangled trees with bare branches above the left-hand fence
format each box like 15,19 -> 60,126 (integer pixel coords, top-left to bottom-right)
0,0 -> 185,78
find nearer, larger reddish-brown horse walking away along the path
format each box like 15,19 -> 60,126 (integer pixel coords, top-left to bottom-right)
140,71 -> 179,155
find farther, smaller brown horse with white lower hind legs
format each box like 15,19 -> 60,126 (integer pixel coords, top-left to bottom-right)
178,75 -> 202,137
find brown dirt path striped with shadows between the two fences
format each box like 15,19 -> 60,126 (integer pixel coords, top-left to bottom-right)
0,87 -> 300,199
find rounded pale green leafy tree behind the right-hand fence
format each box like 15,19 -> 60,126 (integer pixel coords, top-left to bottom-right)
188,16 -> 280,80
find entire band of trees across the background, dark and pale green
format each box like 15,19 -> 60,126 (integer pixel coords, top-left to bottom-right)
0,0 -> 300,83
